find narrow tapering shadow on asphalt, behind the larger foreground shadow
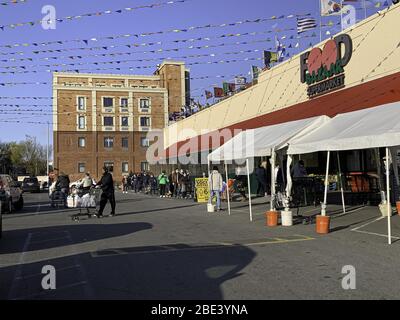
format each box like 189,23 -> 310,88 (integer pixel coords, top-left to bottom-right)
0,222 -> 153,254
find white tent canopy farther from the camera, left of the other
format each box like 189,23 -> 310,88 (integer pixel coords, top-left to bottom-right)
208,116 -> 330,162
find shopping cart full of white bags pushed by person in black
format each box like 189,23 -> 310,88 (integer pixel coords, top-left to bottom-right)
71,188 -> 102,221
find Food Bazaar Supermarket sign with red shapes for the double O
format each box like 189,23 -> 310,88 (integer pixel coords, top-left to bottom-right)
300,34 -> 353,98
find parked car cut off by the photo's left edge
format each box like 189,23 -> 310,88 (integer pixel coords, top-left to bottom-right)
0,175 -> 24,238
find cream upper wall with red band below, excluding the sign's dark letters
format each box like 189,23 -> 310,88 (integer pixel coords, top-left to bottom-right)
164,4 -> 400,165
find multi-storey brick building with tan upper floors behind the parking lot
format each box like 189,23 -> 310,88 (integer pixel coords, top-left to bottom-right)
53,61 -> 190,181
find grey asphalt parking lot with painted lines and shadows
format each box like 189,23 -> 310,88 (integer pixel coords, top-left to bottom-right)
0,193 -> 400,300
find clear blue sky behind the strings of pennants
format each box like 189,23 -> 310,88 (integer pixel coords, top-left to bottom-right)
0,0 -> 385,143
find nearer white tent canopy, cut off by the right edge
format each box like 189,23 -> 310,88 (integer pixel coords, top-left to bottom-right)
287,102 -> 400,154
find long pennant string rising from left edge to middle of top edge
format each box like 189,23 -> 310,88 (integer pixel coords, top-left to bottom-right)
0,0 -> 193,31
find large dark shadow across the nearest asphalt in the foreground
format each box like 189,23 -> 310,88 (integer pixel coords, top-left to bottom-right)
0,244 -> 256,300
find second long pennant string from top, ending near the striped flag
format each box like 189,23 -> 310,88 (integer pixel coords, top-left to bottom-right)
0,13 -> 311,49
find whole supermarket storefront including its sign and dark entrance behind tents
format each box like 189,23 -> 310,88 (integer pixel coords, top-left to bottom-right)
153,5 -> 400,205
